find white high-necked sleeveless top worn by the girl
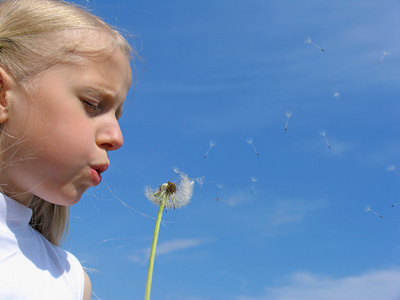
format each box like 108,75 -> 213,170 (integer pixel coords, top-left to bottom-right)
0,194 -> 84,300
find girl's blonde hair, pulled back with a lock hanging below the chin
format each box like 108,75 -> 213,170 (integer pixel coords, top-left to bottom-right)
0,0 -> 134,246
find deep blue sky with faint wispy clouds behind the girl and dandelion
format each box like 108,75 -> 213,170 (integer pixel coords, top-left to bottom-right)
65,0 -> 400,300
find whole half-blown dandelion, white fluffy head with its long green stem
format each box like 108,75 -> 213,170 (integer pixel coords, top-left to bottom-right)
144,172 -> 194,300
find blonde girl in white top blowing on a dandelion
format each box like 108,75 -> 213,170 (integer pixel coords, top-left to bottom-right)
0,0 -> 132,300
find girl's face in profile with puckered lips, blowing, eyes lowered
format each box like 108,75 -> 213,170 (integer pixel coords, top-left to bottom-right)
0,50 -> 132,206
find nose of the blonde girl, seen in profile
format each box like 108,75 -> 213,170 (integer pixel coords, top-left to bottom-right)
96,120 -> 124,151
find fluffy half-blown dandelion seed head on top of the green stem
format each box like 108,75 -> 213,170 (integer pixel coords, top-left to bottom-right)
145,173 -> 194,209
